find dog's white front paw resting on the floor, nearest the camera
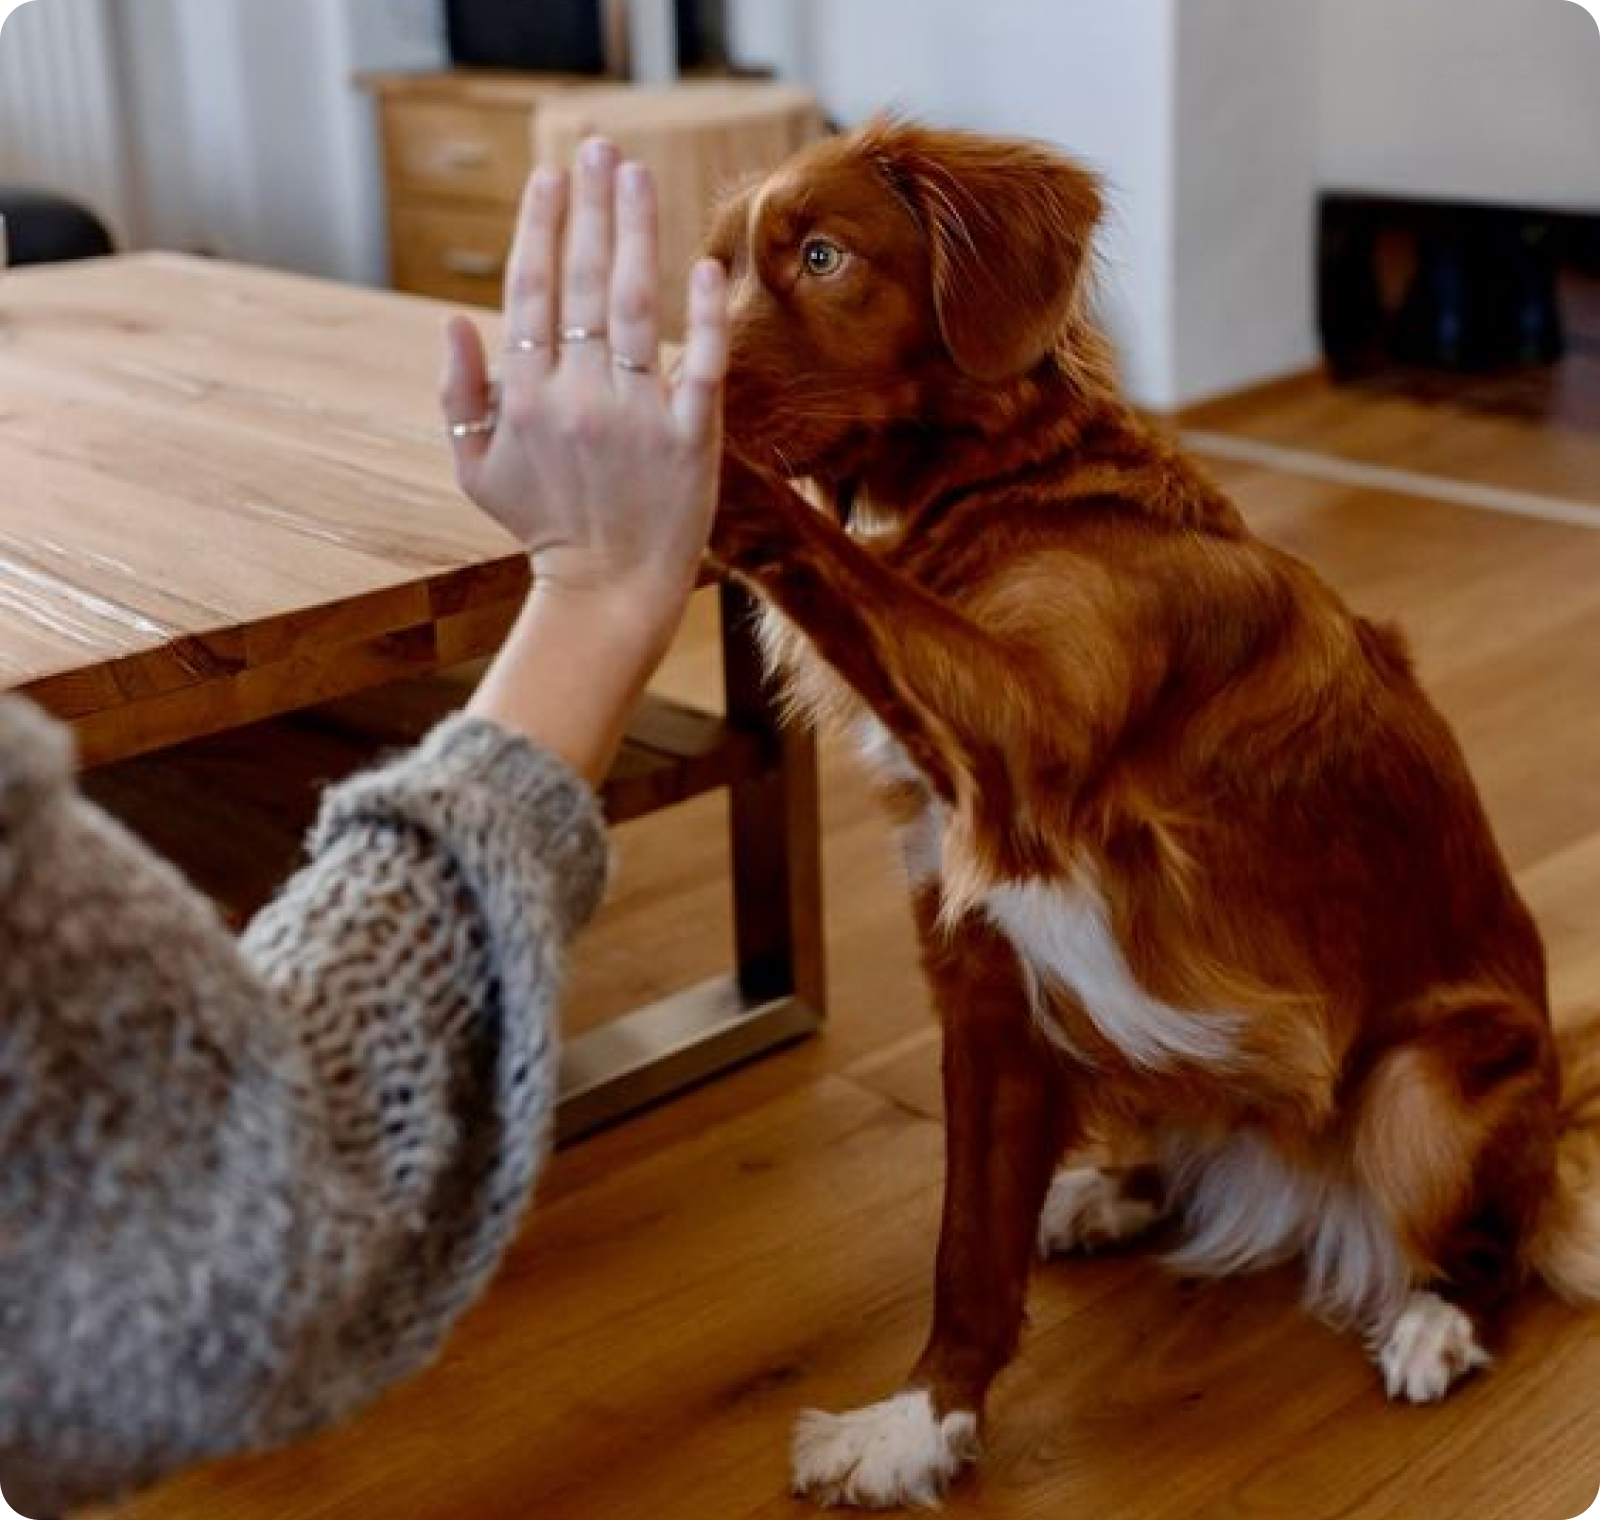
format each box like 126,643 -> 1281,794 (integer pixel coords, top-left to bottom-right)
790,1389 -> 978,1509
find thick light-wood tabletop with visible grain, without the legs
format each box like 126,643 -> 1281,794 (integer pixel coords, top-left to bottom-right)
0,254 -> 526,763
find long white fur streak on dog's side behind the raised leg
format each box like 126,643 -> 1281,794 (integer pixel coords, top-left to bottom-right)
984,874 -> 1240,1070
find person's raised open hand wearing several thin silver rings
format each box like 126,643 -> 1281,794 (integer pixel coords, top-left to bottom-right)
442,139 -> 728,649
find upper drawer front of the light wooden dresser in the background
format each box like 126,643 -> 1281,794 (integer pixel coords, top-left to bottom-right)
384,101 -> 533,203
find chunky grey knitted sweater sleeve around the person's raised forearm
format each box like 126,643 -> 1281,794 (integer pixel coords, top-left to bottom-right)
245,718 -> 606,1438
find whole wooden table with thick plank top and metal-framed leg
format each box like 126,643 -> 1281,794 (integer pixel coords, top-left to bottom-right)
0,254 -> 824,1131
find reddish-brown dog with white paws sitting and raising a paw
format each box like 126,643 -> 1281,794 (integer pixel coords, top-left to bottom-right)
712,122 -> 1600,1506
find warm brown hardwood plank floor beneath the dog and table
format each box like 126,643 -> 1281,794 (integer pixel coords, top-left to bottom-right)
90,384 -> 1600,1520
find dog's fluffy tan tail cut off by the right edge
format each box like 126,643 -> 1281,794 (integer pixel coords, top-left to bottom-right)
1533,1016 -> 1600,1306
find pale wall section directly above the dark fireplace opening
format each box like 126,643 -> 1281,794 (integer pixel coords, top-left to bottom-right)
1318,0 -> 1600,211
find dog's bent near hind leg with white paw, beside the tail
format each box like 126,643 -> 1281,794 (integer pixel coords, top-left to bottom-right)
1355,990 -> 1558,1403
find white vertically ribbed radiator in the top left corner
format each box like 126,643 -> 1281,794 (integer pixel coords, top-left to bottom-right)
0,0 -> 133,238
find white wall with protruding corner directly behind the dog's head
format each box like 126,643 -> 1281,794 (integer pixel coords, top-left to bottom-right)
730,0 -> 1317,408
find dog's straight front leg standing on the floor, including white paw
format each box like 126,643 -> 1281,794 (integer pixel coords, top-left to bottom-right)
792,904 -> 1070,1509
